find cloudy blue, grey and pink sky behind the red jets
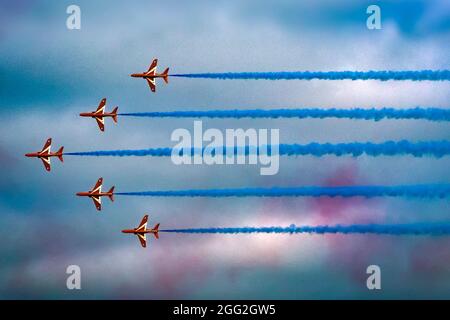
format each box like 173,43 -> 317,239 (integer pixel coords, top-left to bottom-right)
0,0 -> 450,299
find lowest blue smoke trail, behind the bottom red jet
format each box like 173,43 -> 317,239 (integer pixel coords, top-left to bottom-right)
160,223 -> 450,236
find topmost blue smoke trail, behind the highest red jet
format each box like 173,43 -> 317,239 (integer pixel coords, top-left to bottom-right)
170,70 -> 450,81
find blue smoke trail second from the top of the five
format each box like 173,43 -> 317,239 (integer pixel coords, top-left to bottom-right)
119,107 -> 450,121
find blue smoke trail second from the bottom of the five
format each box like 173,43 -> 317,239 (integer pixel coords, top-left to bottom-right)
115,184 -> 450,198
